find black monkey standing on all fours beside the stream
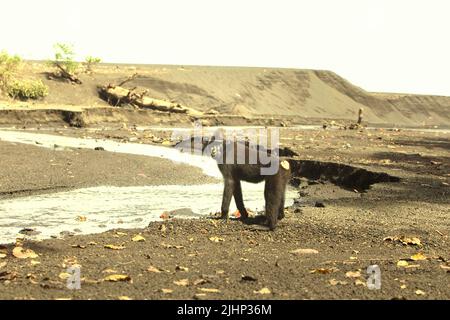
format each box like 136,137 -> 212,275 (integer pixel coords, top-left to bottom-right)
202,137 -> 291,230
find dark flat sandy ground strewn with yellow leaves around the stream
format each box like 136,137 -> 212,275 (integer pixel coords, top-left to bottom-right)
0,125 -> 450,299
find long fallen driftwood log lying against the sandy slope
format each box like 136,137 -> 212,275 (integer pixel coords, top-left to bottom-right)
99,74 -> 202,115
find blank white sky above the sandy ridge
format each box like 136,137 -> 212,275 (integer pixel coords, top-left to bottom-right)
0,0 -> 450,96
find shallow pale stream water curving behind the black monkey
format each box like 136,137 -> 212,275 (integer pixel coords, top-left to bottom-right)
0,131 -> 297,243
